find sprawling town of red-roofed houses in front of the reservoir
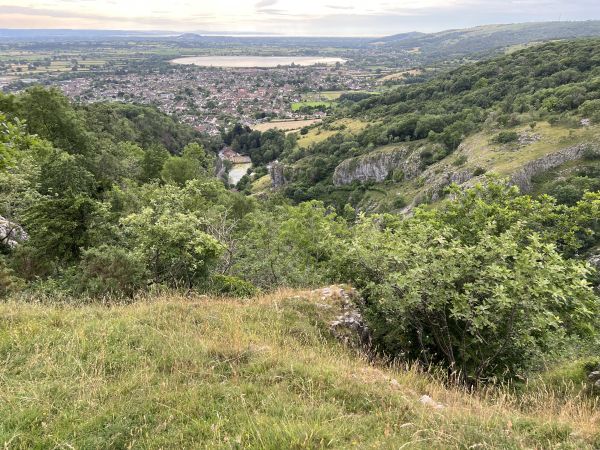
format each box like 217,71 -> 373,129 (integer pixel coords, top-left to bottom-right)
4,60 -> 375,135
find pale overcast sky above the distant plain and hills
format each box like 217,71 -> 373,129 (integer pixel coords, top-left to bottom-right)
0,0 -> 600,36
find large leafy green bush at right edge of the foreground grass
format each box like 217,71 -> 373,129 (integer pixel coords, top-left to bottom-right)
340,179 -> 600,383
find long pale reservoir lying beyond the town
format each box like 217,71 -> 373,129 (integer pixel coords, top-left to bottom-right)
171,56 -> 346,68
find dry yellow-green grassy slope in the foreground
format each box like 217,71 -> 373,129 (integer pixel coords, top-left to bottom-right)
0,291 -> 600,449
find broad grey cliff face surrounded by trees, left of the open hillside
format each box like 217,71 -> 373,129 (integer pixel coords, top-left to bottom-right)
333,147 -> 420,186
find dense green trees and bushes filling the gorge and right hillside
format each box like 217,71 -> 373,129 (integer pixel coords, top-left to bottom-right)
0,40 -> 600,383
